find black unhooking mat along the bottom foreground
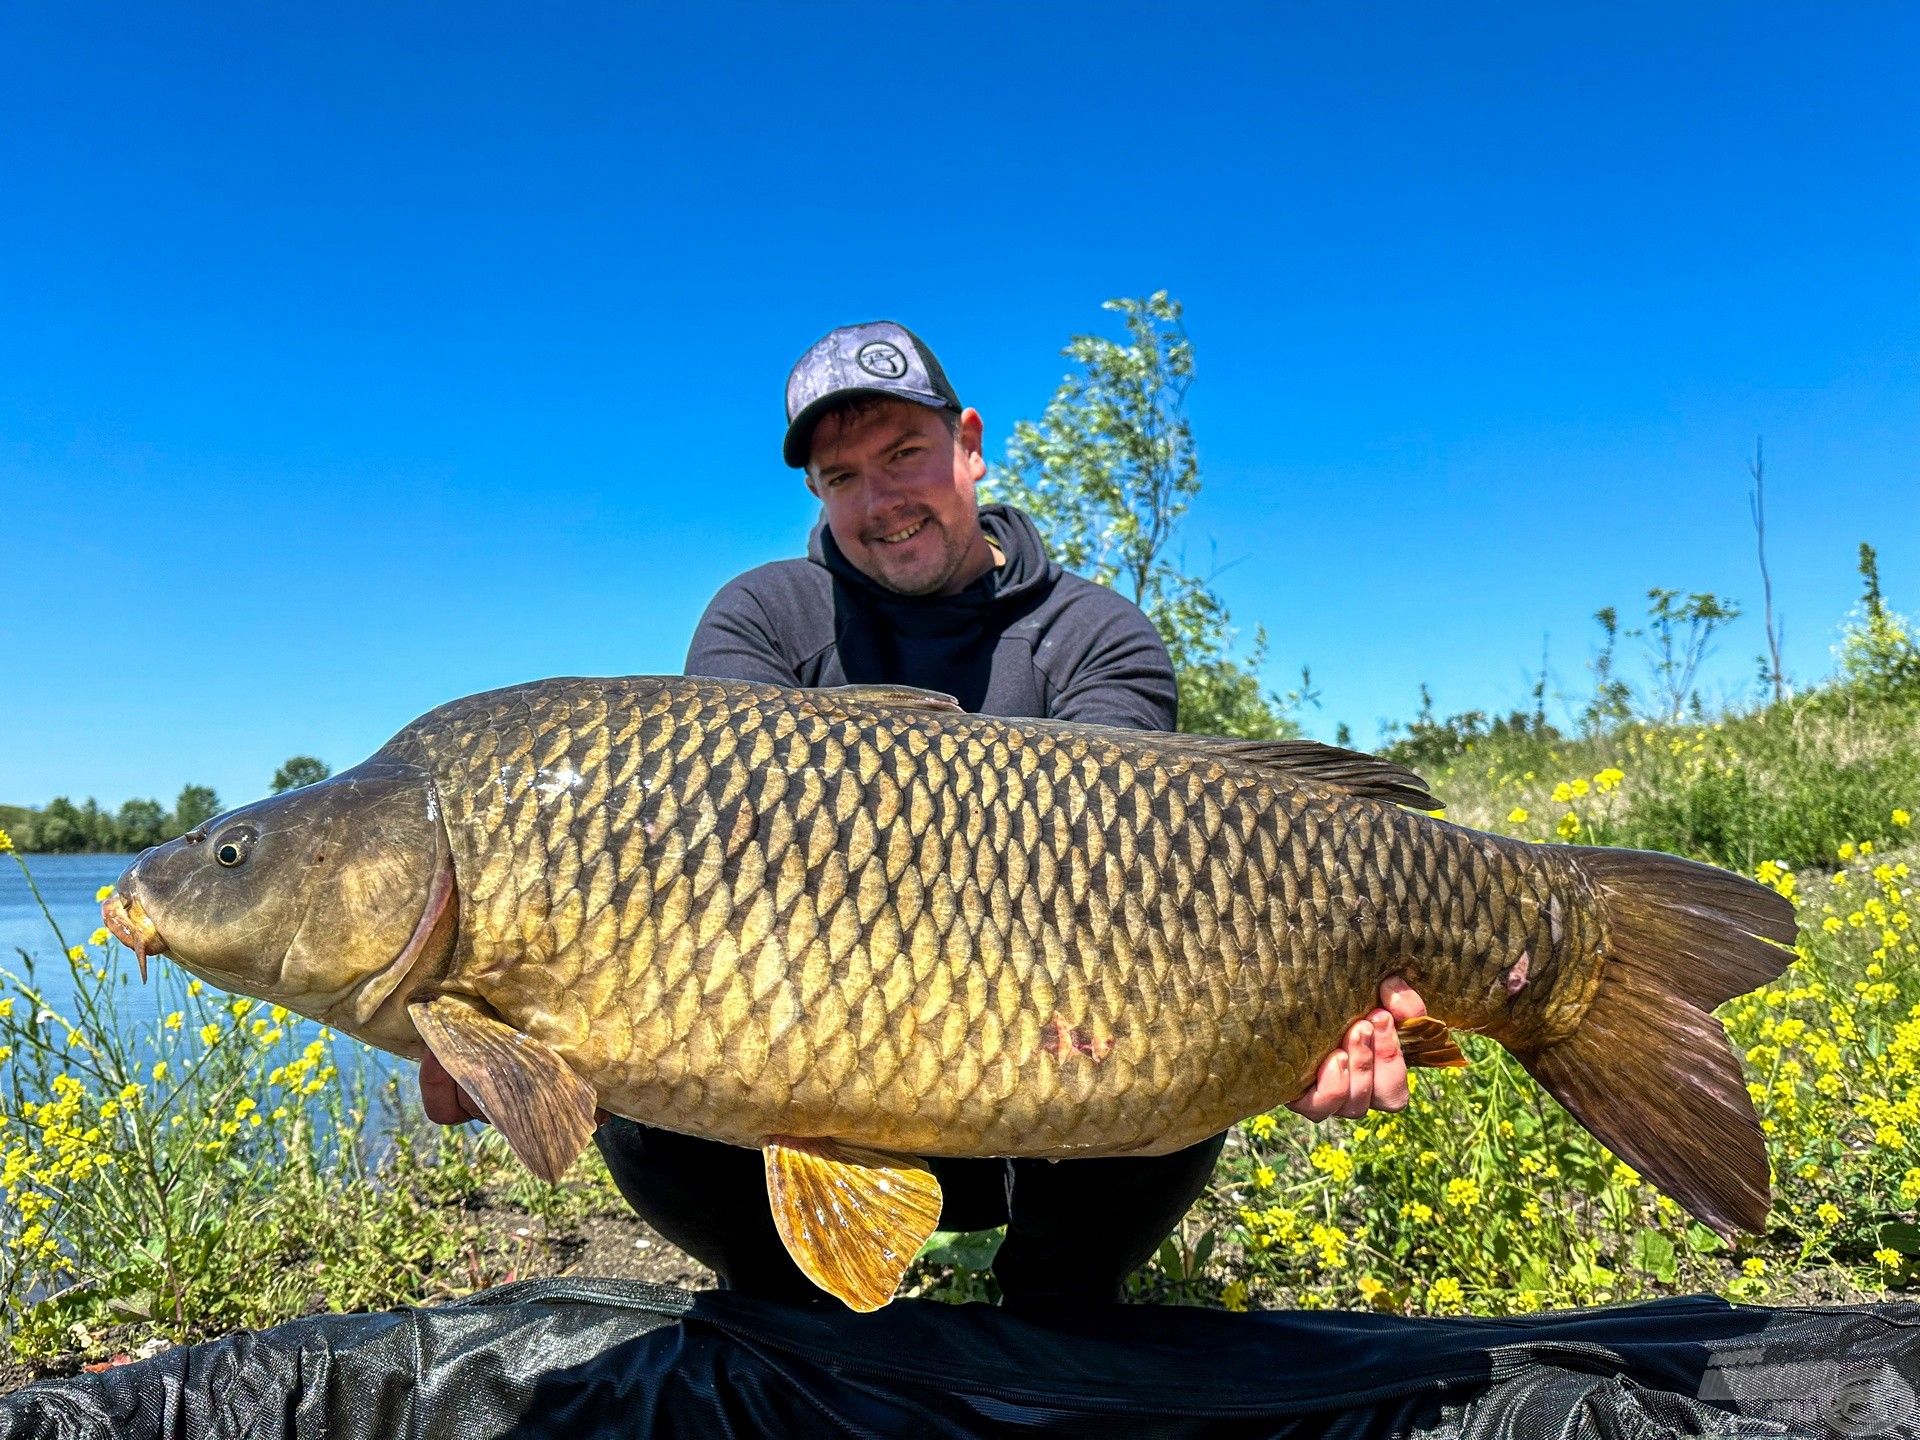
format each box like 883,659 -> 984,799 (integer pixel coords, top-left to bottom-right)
0,1281 -> 1920,1440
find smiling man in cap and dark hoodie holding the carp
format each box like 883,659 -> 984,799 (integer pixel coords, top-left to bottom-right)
420,321 -> 1425,1306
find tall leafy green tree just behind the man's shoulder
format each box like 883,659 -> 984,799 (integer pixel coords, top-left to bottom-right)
995,290 -> 1311,739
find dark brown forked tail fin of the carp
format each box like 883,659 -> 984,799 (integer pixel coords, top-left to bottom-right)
1519,847 -> 1795,1236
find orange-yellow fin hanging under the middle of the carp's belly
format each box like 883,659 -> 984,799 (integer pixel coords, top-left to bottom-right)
766,1135 -> 941,1311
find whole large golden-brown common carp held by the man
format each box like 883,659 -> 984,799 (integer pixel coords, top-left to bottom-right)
104,678 -> 1793,1309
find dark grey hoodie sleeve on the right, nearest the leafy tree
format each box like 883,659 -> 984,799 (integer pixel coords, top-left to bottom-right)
1043,582 -> 1179,730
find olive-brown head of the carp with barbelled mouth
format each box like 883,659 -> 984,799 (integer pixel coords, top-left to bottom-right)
100,760 -> 459,1033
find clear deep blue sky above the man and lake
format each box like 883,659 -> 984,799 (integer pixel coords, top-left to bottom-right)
0,4 -> 1920,804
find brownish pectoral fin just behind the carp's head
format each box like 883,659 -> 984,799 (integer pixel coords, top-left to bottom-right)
407,995 -> 595,1181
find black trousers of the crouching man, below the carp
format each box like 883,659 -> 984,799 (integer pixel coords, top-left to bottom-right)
595,1117 -> 1227,1308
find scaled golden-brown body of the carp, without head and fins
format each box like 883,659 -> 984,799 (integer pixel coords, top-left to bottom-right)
390,682 -> 1596,1156
